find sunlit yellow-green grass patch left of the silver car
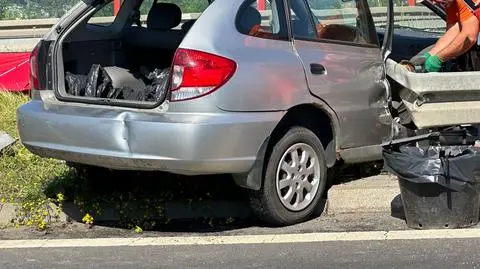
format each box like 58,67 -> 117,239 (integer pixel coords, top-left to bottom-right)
0,92 -> 69,230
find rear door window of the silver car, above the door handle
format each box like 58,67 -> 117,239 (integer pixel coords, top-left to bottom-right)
292,0 -> 376,45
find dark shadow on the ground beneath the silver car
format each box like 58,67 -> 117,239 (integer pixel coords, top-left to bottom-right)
45,161 -> 381,233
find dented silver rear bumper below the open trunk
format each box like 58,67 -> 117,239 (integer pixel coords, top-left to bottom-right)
17,100 -> 283,175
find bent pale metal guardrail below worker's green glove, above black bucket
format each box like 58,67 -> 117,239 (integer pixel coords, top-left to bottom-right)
386,0 -> 480,129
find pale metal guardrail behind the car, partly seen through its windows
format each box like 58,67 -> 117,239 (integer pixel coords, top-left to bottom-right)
0,6 -> 445,39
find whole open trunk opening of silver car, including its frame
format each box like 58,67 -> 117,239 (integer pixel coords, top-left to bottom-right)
54,1 -> 195,108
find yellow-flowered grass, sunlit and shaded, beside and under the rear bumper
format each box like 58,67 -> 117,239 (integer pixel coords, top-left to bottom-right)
0,92 -> 246,230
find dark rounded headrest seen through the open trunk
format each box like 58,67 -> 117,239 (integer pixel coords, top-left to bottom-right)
147,3 -> 182,30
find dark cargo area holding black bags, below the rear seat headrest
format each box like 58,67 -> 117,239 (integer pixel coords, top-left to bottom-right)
58,27 -> 180,103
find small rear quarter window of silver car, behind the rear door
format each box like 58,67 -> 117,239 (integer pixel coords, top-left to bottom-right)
236,0 -> 288,39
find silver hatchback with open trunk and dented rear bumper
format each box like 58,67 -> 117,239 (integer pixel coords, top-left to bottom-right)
18,0 -> 464,225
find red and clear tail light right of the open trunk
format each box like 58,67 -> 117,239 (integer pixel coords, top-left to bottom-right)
170,49 -> 237,101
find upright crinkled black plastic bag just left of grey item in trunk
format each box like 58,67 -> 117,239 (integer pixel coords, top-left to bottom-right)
85,64 -> 113,98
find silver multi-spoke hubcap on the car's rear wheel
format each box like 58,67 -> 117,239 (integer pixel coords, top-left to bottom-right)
276,143 -> 320,211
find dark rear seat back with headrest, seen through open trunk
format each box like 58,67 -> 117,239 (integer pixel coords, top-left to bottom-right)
124,3 -> 185,49
